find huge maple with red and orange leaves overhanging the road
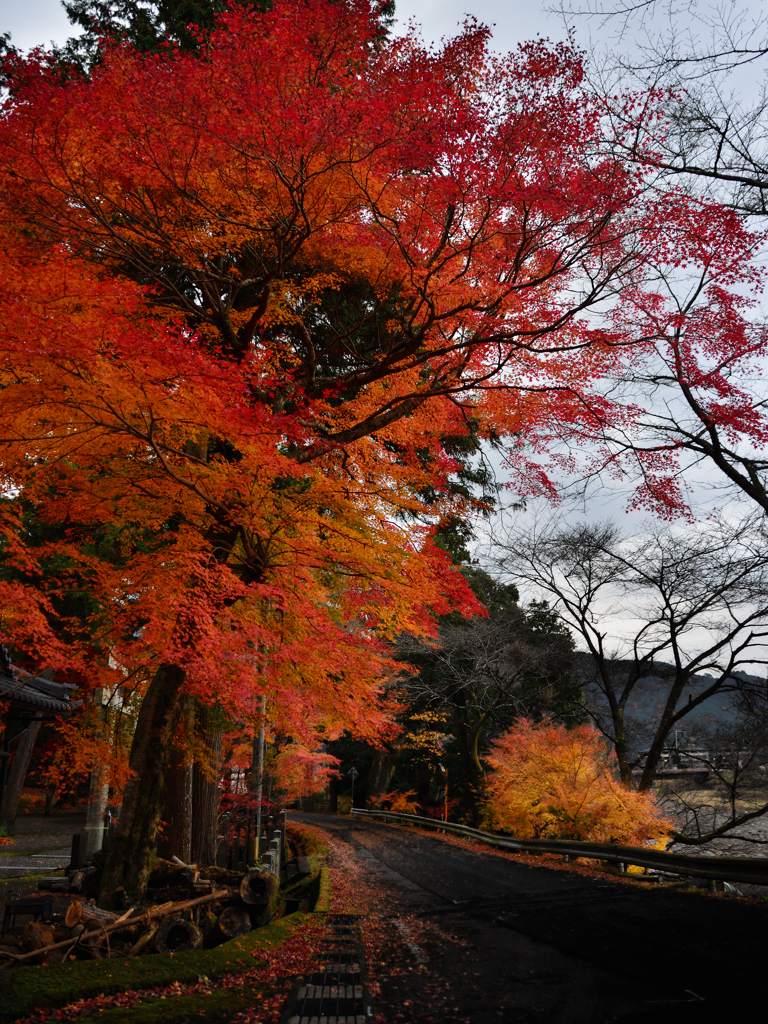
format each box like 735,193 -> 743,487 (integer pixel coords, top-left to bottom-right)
0,0 -> 757,892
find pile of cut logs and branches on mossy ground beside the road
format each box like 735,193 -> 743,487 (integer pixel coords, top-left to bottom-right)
0,861 -> 280,967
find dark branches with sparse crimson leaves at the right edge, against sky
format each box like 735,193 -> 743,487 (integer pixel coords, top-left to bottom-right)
591,290 -> 768,515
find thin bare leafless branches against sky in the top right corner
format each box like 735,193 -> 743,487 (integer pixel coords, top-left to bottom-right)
556,0 -> 768,215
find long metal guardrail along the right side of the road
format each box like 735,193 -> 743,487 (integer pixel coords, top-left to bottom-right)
351,807 -> 768,886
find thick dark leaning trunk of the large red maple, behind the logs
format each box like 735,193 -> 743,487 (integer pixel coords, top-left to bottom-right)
99,665 -> 184,905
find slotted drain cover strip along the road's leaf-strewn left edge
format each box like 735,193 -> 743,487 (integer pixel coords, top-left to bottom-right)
281,913 -> 374,1024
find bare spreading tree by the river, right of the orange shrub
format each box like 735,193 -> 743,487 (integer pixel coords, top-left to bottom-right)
501,518 -> 768,842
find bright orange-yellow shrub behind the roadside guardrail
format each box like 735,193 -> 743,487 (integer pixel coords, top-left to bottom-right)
485,719 -> 672,844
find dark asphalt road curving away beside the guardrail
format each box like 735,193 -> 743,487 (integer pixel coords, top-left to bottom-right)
292,814 -> 768,1024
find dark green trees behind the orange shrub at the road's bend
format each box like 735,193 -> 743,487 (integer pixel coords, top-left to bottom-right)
329,564 -> 583,821
